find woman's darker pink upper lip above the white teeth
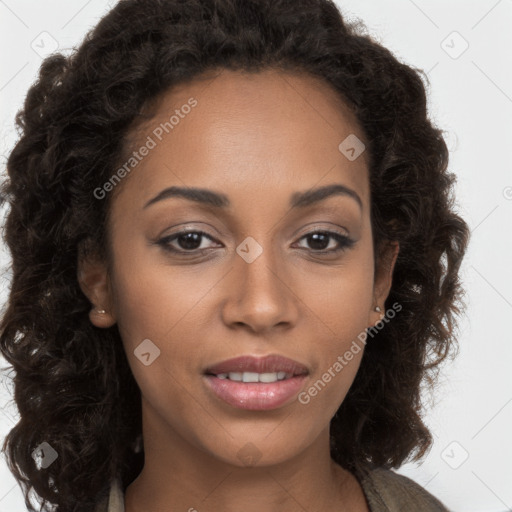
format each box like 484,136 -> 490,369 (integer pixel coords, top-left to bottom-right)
205,355 -> 309,375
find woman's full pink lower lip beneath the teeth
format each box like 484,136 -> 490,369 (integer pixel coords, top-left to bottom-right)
205,375 -> 307,411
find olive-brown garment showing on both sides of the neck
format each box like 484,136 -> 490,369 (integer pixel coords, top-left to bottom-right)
94,468 -> 449,512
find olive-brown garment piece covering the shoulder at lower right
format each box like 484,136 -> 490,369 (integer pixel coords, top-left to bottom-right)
360,468 -> 449,512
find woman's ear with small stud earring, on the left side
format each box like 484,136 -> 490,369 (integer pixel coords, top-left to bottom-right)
77,247 -> 116,328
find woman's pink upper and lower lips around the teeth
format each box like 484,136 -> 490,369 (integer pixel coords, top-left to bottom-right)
204,355 -> 309,411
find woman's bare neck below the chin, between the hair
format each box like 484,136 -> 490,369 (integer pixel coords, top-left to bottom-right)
125,400 -> 368,512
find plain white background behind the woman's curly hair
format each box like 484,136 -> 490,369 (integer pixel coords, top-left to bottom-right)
0,0 -> 512,512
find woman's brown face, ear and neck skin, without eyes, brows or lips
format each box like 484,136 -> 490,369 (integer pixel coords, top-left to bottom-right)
79,70 -> 398,512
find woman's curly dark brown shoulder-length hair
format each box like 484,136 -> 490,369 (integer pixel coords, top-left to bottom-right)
0,0 -> 469,512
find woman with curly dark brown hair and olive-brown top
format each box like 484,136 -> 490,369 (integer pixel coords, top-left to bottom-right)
0,0 -> 468,512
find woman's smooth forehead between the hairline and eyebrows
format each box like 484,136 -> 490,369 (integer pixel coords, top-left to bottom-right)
112,66 -> 369,214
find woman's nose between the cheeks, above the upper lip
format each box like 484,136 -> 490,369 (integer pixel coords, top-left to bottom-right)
222,238 -> 299,333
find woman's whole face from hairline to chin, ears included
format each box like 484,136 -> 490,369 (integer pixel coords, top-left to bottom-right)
79,70 -> 396,465
